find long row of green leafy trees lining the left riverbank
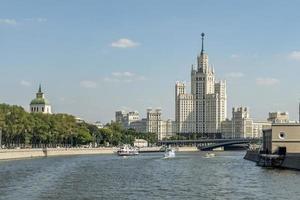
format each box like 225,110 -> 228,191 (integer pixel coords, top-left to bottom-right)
0,104 -> 157,148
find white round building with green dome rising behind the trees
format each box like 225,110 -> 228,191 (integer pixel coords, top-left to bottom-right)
29,85 -> 52,114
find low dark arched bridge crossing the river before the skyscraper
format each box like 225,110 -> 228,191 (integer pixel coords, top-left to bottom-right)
159,138 -> 259,151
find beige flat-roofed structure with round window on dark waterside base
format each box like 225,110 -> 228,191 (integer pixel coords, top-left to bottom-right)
244,123 -> 300,170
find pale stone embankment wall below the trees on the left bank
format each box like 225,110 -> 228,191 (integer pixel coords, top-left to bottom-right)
0,148 -> 115,160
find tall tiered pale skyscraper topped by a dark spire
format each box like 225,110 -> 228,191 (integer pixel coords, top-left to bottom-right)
175,33 -> 227,137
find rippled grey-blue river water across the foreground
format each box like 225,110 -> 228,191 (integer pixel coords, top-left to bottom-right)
0,152 -> 300,200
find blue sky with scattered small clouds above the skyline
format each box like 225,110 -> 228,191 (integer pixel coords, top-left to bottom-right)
0,0 -> 300,122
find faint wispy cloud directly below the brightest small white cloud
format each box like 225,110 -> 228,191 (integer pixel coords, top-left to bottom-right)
104,72 -> 147,83
